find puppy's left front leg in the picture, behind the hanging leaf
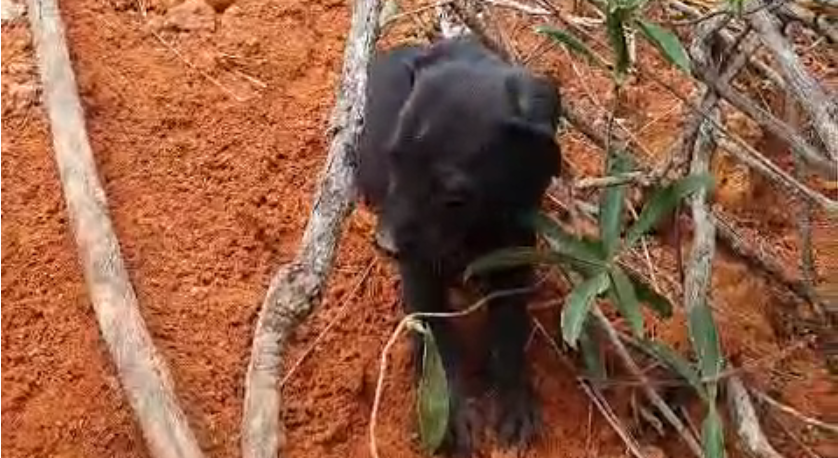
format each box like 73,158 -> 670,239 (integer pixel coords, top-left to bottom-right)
399,256 -> 474,455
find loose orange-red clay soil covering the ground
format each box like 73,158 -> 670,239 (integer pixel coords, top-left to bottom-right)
2,0 -> 838,458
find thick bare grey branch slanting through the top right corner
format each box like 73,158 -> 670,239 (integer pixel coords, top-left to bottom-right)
750,0 -> 838,161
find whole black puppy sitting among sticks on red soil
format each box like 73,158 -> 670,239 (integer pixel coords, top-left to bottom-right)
357,37 -> 560,453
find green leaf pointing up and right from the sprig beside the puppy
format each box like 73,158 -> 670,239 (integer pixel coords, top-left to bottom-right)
626,173 -> 713,248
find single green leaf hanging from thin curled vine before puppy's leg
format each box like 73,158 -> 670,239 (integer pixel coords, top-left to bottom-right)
416,330 -> 449,452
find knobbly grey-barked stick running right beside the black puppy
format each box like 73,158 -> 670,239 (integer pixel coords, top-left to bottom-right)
241,0 -> 381,458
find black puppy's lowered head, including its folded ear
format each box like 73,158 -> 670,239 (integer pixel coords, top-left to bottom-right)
383,61 -> 560,258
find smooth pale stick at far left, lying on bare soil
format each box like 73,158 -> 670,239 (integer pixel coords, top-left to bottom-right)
28,0 -> 203,458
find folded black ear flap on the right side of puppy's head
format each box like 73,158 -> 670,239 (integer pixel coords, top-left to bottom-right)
503,116 -> 561,178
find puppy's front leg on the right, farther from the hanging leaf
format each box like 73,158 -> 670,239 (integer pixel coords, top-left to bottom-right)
484,262 -> 541,447
